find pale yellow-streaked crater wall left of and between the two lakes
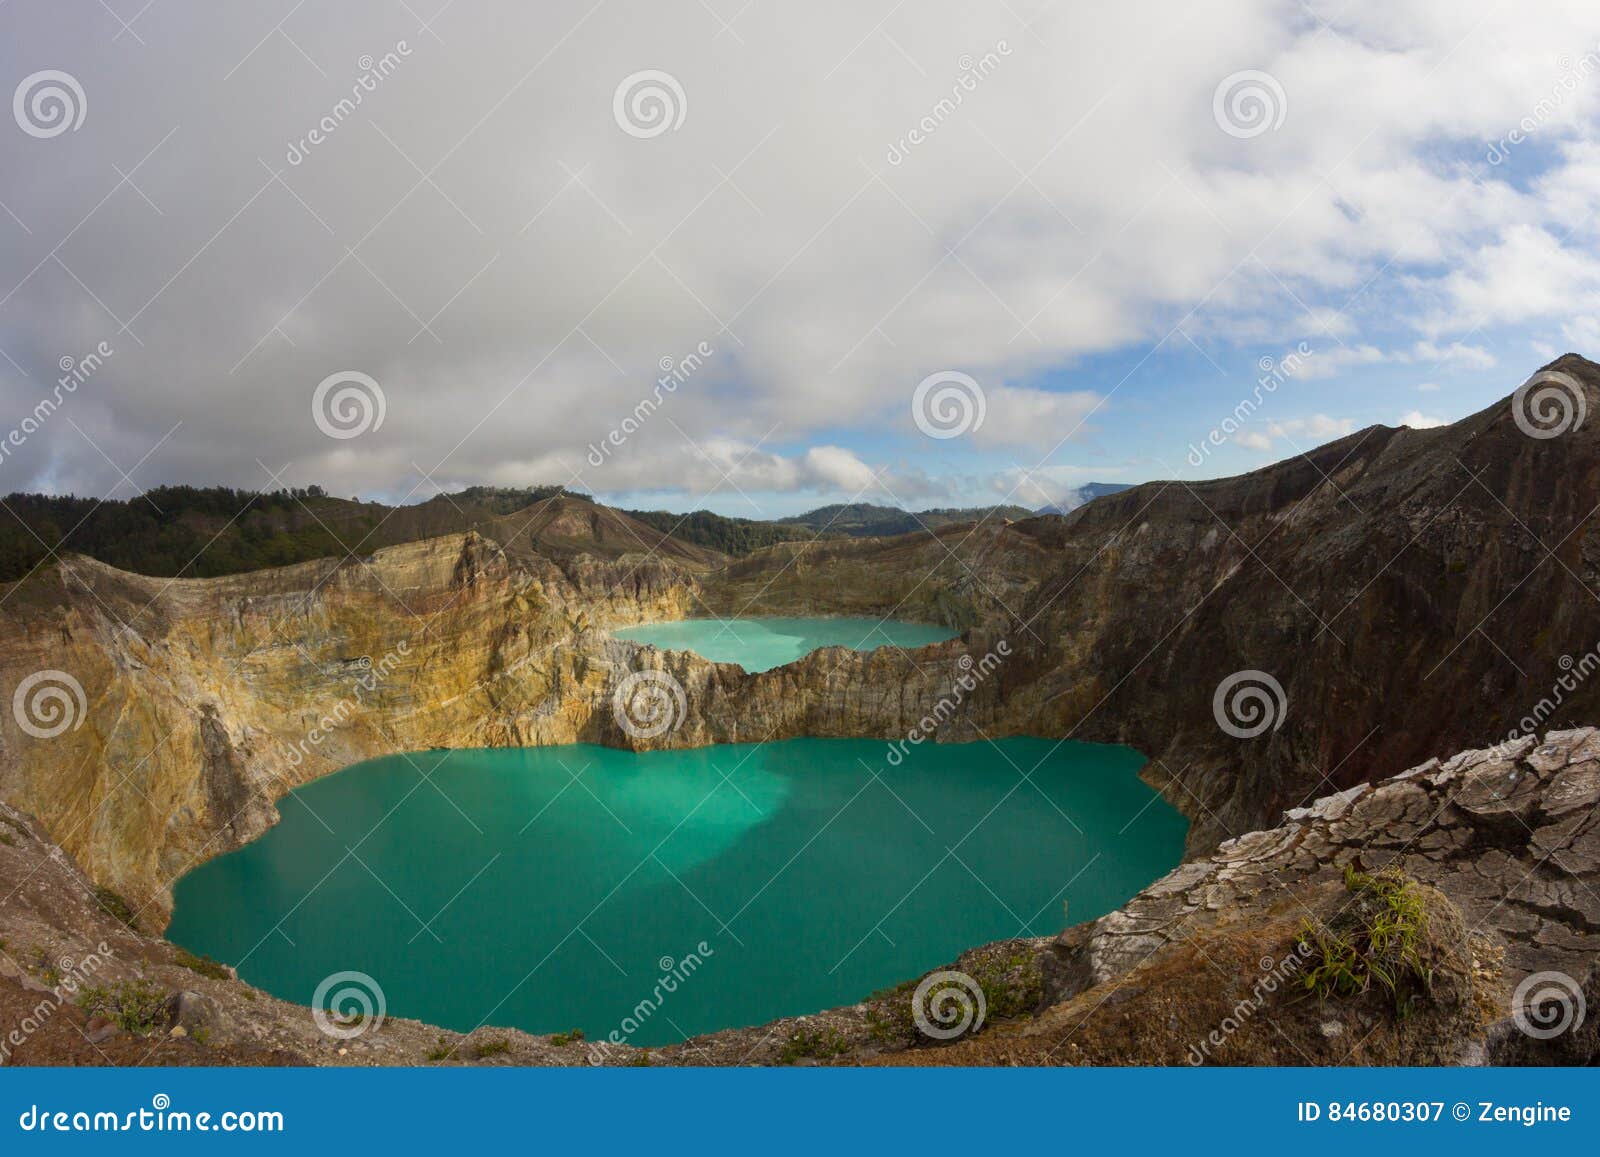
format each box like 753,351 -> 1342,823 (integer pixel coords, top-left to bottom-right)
0,533 -> 1017,914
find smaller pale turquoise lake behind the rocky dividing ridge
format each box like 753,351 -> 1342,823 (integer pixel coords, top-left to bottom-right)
613,618 -> 957,671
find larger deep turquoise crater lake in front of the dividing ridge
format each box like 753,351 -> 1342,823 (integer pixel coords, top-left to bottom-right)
168,738 -> 1187,1045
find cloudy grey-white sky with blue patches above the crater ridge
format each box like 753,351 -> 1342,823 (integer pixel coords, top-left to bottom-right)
0,0 -> 1600,517
